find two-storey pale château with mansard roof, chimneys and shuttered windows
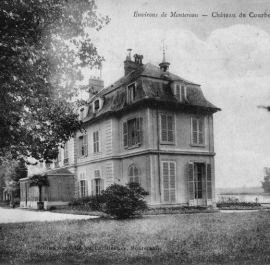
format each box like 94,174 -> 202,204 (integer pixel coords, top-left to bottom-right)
21,50 -> 220,208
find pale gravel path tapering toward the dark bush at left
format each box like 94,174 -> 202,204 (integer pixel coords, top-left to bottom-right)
0,207 -> 98,224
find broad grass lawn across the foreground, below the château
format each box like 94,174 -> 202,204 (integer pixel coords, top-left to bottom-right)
0,212 -> 270,264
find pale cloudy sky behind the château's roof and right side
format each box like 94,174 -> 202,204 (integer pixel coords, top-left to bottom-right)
85,0 -> 270,188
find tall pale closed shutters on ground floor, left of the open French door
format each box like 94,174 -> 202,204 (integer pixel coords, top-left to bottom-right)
162,162 -> 175,202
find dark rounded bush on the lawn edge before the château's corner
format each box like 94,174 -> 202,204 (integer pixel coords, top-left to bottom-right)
103,182 -> 149,219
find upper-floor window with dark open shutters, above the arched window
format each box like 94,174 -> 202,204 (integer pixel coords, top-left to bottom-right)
123,118 -> 142,148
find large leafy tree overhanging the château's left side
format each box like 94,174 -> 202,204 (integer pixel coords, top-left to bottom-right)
0,0 -> 109,162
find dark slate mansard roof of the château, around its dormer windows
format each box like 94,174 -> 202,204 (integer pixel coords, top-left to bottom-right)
84,63 -> 220,122
